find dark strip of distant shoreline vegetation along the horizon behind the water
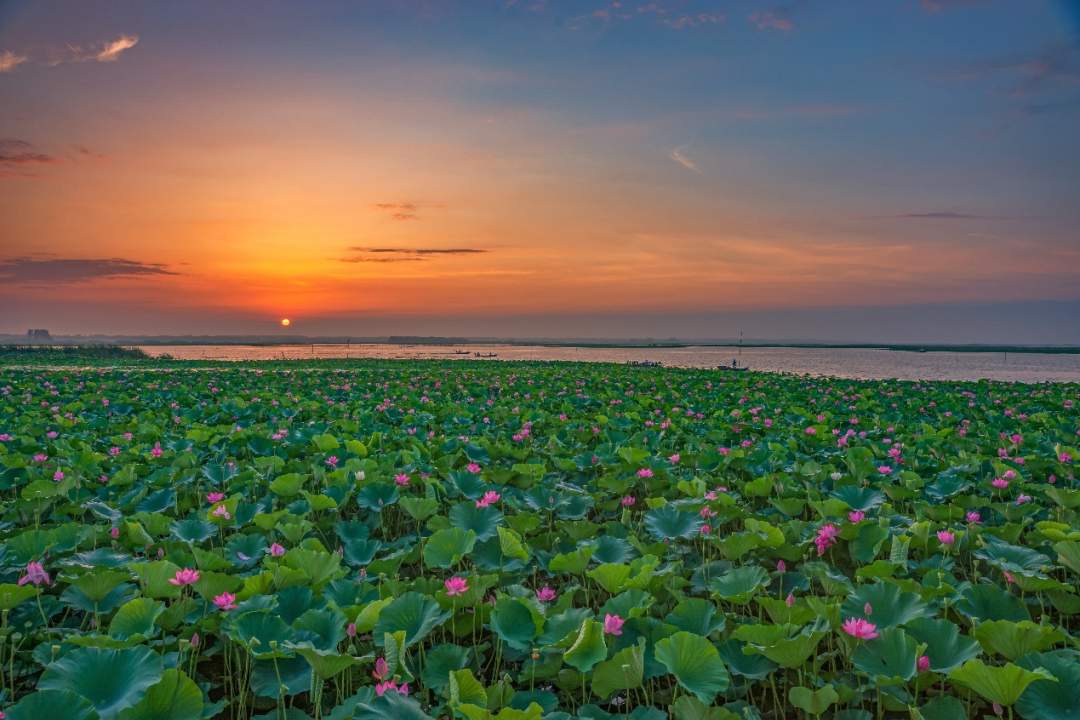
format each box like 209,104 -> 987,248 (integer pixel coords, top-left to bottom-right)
0,335 -> 1080,357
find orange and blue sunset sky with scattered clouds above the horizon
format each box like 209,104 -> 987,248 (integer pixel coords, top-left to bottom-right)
0,0 -> 1080,343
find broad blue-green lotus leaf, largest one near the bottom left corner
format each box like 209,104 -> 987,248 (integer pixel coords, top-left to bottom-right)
38,647 -> 162,720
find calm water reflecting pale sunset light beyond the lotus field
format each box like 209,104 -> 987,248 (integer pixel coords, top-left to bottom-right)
141,344 -> 1080,382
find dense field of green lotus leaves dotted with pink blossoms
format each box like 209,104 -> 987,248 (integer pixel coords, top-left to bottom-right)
0,362 -> 1080,720
